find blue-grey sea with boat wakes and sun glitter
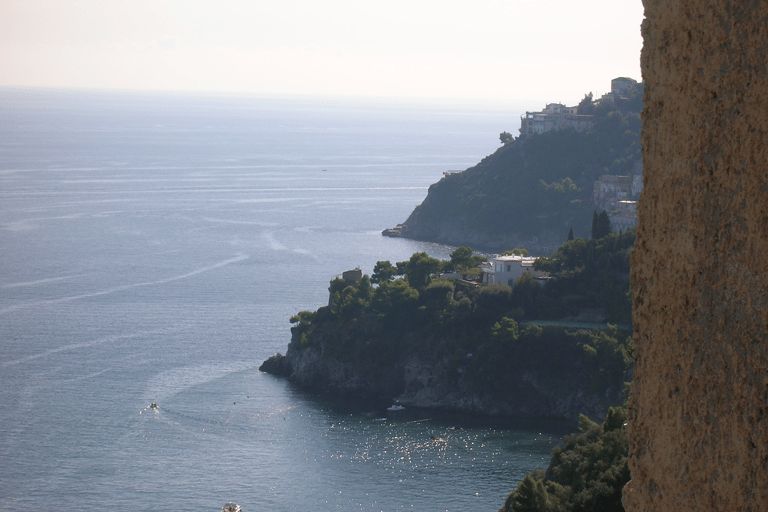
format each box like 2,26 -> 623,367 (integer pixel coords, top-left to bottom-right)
0,88 -> 565,512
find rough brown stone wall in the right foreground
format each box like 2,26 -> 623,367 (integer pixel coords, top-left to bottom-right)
624,0 -> 768,512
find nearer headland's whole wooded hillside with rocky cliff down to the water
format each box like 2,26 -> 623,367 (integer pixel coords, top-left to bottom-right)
263,233 -> 634,422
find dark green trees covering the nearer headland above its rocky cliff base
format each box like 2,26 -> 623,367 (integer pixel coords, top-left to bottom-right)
282,230 -> 633,410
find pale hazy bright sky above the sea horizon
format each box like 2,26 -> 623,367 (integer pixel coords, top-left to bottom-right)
0,0 -> 643,104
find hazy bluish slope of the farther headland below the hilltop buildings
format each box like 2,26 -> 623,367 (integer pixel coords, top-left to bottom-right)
390,91 -> 642,254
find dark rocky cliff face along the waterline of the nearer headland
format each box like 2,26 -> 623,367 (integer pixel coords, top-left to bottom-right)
261,328 -> 624,422
